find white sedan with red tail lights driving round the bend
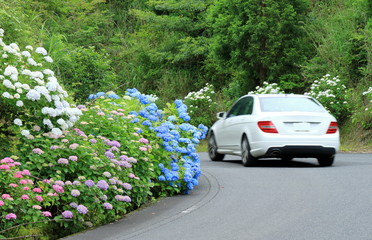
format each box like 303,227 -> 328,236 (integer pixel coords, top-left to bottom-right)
208,94 -> 340,166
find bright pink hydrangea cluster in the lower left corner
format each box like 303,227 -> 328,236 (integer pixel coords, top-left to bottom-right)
0,157 -> 58,231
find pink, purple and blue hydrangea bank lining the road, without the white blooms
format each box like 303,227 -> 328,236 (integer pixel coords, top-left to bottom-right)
0,89 -> 207,237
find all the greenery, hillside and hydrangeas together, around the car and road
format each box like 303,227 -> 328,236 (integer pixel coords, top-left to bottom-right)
0,0 -> 372,239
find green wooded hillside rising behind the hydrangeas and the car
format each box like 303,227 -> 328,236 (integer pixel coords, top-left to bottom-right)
0,0 -> 372,124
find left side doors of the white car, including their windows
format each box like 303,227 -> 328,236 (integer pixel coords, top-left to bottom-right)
218,96 -> 253,151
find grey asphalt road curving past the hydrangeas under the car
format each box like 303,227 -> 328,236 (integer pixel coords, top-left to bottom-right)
67,153 -> 372,240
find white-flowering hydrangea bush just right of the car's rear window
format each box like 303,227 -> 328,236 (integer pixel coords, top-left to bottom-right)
305,74 -> 350,121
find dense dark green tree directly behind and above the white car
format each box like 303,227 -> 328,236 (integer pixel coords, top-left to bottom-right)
207,0 -> 308,96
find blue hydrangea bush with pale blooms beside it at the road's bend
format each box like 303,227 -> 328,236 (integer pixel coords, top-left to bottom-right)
81,89 -> 207,195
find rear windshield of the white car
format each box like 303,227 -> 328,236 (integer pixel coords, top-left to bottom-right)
260,96 -> 324,112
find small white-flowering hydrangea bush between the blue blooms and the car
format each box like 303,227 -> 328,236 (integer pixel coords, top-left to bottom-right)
184,83 -> 218,126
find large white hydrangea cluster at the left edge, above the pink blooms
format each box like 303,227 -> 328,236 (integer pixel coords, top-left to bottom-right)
0,29 -> 82,138
